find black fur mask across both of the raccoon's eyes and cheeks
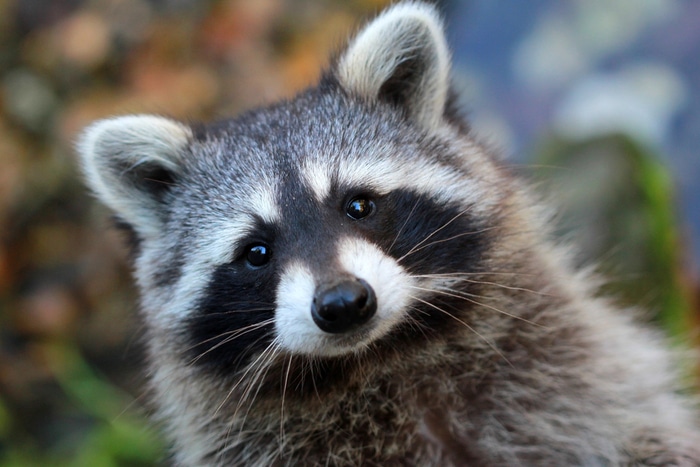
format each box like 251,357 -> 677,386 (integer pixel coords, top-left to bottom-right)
183,177 -> 486,374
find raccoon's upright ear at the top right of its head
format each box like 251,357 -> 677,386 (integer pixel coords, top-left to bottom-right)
336,2 -> 450,130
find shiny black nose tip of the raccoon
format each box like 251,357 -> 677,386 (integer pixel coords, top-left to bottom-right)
311,279 -> 377,334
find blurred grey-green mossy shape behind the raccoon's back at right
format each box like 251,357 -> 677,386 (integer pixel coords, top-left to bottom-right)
537,134 -> 691,341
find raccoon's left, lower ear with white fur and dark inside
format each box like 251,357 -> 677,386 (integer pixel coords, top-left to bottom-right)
77,115 -> 192,237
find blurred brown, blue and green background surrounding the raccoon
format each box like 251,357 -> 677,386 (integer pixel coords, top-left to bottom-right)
0,0 -> 700,467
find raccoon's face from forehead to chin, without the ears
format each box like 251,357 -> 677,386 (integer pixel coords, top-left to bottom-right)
166,106 -> 485,368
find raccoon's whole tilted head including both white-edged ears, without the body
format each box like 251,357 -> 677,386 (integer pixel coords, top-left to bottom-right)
79,3 -> 499,372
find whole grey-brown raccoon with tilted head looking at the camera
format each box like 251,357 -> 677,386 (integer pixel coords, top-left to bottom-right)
78,2 -> 700,466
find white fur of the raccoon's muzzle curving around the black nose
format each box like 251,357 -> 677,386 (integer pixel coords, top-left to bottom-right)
275,239 -> 413,356
